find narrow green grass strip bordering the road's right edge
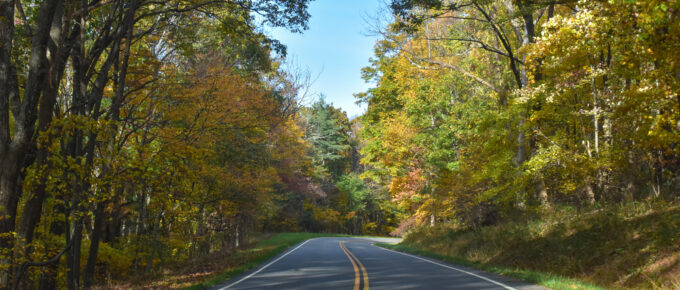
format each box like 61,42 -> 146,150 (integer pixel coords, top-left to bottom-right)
375,243 -> 604,289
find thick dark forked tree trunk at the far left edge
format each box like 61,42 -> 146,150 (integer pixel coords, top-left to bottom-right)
0,1 -> 60,287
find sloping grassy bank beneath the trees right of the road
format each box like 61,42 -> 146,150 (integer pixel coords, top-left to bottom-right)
387,203 -> 680,289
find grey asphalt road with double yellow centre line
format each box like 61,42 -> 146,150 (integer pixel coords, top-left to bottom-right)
213,238 -> 544,290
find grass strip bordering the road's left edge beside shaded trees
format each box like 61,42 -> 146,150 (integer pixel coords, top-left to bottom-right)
182,233 -> 349,290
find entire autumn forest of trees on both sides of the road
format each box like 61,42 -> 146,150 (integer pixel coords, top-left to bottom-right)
0,0 -> 680,289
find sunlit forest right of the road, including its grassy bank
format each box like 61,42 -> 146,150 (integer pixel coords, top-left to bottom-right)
357,0 -> 680,289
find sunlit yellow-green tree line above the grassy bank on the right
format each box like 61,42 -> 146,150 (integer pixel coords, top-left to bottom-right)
358,0 -> 680,232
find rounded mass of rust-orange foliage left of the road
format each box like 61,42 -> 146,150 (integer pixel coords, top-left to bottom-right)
140,55 -> 309,220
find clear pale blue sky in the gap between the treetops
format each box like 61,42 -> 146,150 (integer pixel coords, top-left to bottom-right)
270,0 -> 388,119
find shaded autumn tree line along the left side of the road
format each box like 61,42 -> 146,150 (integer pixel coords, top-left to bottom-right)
0,0 -> 322,289
